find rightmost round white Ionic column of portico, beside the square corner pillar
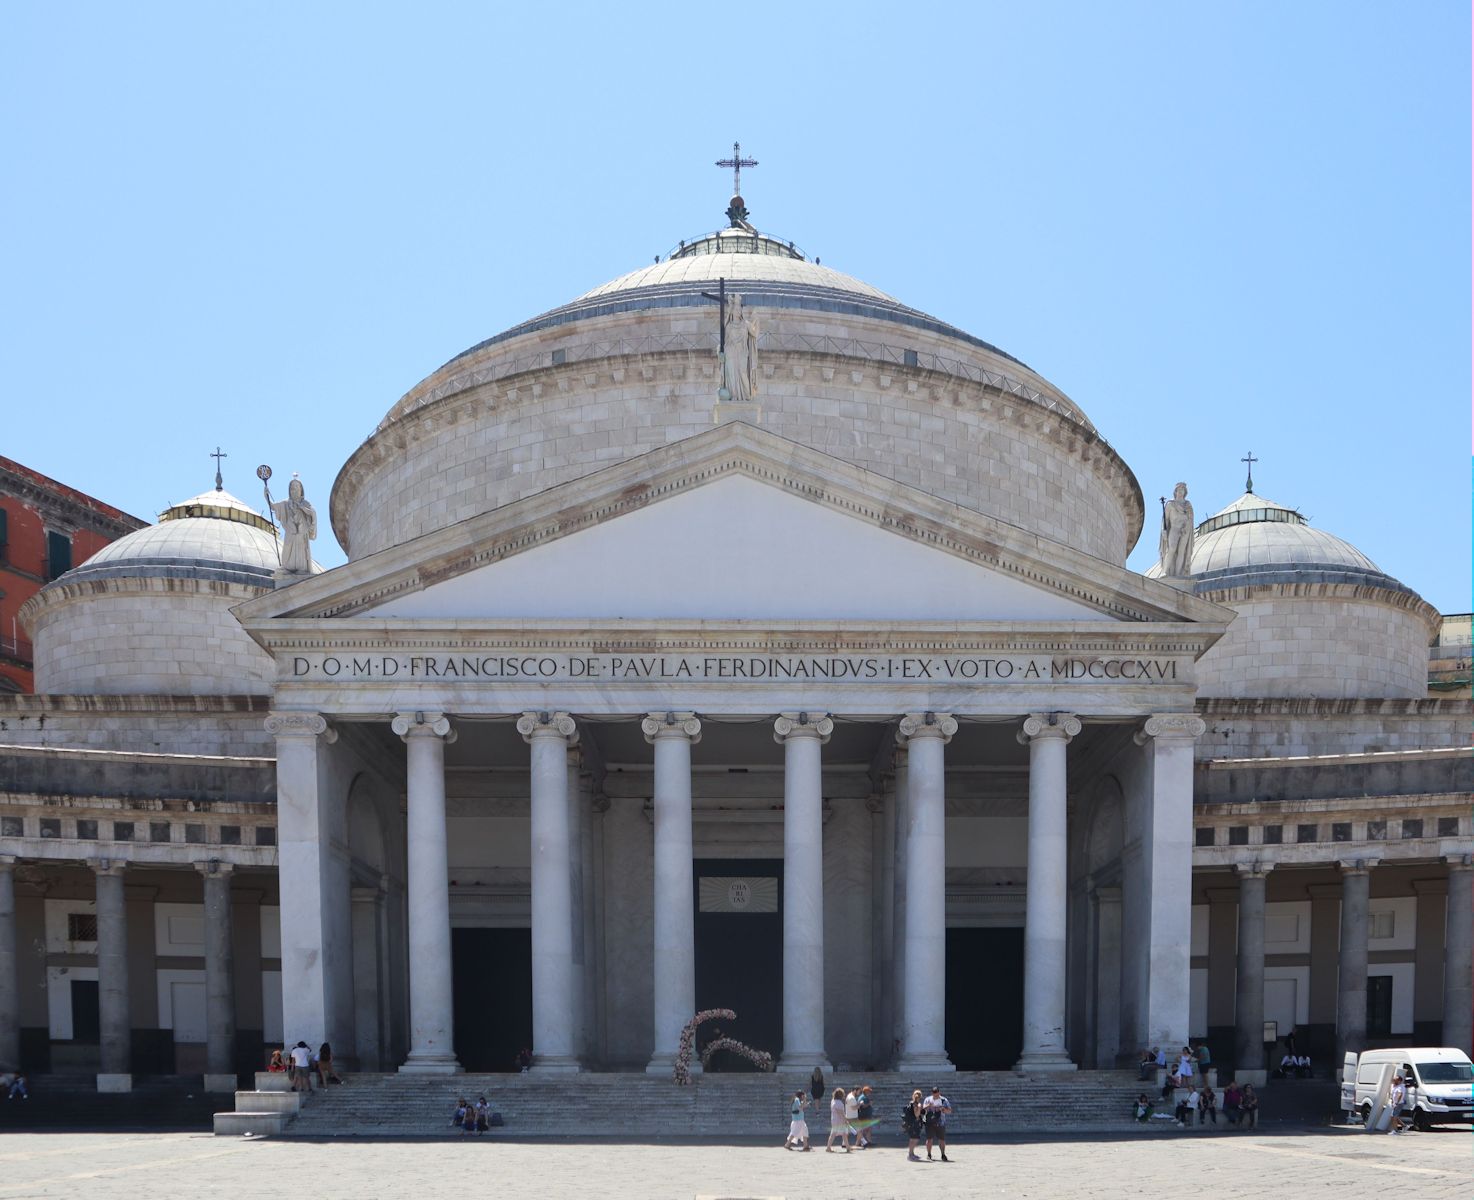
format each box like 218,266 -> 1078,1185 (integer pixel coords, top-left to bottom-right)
1014,712 -> 1080,1072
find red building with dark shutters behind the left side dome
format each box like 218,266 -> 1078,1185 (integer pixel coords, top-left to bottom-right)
0,457 -> 147,691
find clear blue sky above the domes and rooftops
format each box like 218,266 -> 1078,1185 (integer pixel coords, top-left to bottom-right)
0,0 -> 1470,612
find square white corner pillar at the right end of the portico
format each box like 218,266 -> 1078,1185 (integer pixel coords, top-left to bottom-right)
1126,712 -> 1207,1047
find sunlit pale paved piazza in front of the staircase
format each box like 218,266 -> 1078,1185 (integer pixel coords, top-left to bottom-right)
0,1129 -> 1474,1200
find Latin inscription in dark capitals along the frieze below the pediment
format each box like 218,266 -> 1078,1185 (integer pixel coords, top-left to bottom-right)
283,653 -> 1179,684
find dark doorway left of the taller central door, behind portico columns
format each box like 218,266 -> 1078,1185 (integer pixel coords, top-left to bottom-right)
451,929 -> 532,1072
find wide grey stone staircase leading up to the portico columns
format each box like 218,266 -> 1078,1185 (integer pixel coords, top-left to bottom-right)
247,1070 -> 1164,1145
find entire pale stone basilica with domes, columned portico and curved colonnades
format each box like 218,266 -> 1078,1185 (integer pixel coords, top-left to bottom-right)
0,200 -> 1474,1089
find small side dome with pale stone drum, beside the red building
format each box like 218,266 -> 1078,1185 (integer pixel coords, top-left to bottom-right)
21,488 -> 299,696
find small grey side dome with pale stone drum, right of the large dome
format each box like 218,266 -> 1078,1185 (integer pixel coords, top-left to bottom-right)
1147,491 -> 1439,699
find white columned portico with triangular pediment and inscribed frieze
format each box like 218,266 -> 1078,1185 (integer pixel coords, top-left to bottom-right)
237,425 -> 1225,1072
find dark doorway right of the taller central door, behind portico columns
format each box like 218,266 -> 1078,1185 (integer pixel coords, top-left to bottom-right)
946,929 -> 1023,1070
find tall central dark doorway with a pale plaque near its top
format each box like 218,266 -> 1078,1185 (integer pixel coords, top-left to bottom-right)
694,858 -> 783,1072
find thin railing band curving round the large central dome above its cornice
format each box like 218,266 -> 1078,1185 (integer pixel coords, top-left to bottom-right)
397,333 -> 1104,441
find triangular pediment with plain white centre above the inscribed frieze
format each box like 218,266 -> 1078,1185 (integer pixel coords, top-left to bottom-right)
236,423 -> 1229,628
